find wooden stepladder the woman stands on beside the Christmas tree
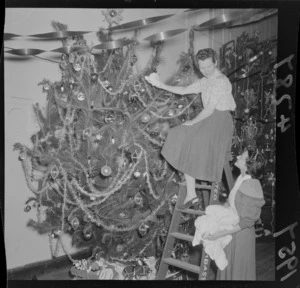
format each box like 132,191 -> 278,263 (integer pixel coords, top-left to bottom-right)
156,158 -> 234,280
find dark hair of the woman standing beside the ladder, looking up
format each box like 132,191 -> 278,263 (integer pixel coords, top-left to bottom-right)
246,150 -> 266,179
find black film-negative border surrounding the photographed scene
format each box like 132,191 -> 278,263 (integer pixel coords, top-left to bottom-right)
0,0 -> 300,288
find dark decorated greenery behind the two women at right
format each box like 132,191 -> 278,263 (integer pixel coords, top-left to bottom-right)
220,31 -> 277,235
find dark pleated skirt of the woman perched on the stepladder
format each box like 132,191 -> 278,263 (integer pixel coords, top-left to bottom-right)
161,109 -> 234,181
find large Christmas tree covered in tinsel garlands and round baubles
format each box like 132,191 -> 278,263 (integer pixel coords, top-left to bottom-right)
14,9 -> 202,258
